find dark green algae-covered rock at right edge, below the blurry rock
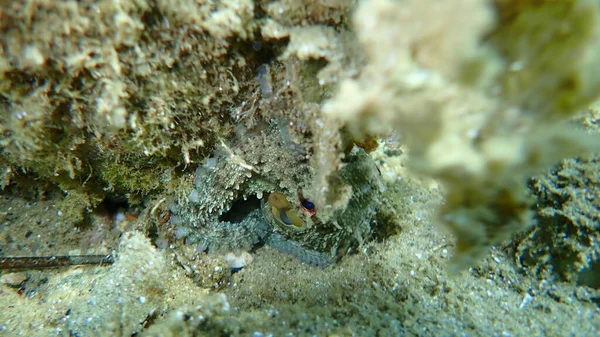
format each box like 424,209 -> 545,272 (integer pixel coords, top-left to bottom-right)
517,155 -> 600,280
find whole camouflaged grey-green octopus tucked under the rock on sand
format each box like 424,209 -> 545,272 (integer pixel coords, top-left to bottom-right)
169,63 -> 383,266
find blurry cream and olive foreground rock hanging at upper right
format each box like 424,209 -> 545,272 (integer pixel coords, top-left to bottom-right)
323,0 -> 600,268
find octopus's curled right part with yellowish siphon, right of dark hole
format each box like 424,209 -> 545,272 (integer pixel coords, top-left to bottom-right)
261,149 -> 382,265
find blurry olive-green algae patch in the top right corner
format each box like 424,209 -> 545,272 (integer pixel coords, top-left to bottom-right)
489,0 -> 600,118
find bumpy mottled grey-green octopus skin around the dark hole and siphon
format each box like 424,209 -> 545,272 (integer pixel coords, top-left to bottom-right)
170,125 -> 383,266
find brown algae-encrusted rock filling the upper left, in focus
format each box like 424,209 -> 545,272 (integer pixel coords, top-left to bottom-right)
0,0 -> 257,208
